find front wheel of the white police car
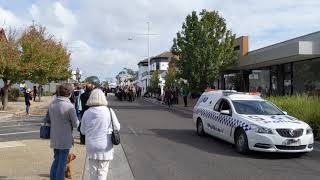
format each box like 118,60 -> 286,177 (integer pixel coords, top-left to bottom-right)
234,128 -> 249,154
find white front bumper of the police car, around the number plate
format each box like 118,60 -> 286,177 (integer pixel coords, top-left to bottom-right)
247,131 -> 314,153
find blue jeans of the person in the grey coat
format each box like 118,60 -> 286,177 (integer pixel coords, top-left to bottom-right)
50,149 -> 70,180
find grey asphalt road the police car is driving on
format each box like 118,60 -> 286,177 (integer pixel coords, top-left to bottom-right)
109,97 -> 320,180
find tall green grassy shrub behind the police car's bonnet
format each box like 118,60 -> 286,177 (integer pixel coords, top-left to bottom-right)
268,96 -> 320,140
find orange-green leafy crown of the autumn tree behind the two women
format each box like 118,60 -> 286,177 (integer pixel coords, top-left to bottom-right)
20,25 -> 71,85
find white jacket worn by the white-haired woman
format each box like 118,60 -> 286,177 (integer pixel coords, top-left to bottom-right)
80,106 -> 120,160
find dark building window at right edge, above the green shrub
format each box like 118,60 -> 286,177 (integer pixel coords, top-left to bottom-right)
293,58 -> 320,95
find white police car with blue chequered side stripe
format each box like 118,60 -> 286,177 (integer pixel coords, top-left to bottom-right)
193,90 -> 313,154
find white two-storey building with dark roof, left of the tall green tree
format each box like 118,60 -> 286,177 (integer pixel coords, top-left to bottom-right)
137,52 -> 173,95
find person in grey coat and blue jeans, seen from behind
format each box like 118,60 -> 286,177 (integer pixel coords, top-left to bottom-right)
45,84 -> 79,180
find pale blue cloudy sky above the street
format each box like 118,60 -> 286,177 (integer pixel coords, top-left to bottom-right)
0,0 -> 320,80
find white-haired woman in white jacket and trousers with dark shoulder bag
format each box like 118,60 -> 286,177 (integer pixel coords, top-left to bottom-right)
80,89 -> 120,180
